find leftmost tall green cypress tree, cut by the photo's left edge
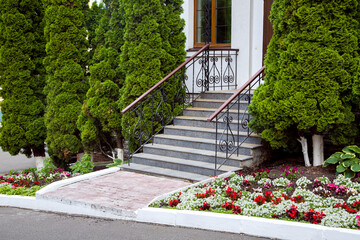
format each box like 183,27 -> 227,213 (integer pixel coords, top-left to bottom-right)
0,0 -> 46,161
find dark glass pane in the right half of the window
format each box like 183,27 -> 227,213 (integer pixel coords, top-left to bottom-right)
216,0 -> 231,44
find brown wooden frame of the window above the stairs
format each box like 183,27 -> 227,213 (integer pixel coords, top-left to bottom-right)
194,0 -> 232,47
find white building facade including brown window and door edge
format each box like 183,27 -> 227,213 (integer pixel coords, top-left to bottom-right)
182,0 -> 273,87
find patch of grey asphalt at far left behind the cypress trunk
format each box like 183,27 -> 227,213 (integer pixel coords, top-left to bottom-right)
0,148 -> 35,174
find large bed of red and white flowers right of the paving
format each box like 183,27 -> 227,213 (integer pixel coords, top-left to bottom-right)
150,167 -> 360,229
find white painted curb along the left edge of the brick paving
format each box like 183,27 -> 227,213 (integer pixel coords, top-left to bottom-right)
35,167 -> 120,198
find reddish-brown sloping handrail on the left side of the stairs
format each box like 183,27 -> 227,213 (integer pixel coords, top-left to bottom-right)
121,44 -> 210,114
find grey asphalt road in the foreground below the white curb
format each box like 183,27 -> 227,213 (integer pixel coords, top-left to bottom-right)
0,207 -> 265,240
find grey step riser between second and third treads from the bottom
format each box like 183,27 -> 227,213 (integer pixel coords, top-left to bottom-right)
144,146 -> 240,167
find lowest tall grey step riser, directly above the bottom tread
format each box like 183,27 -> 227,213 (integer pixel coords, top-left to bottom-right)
133,157 -> 224,176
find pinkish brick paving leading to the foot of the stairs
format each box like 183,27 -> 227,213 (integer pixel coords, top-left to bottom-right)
44,171 -> 191,211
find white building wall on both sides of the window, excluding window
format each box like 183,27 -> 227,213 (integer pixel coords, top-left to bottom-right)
182,0 -> 264,87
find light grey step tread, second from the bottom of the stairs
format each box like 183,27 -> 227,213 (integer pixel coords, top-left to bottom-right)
134,153 -> 241,172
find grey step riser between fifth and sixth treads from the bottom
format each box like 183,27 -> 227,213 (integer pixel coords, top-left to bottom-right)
174,119 -> 247,133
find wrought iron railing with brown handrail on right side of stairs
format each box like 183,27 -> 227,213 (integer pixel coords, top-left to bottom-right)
207,67 -> 265,176
